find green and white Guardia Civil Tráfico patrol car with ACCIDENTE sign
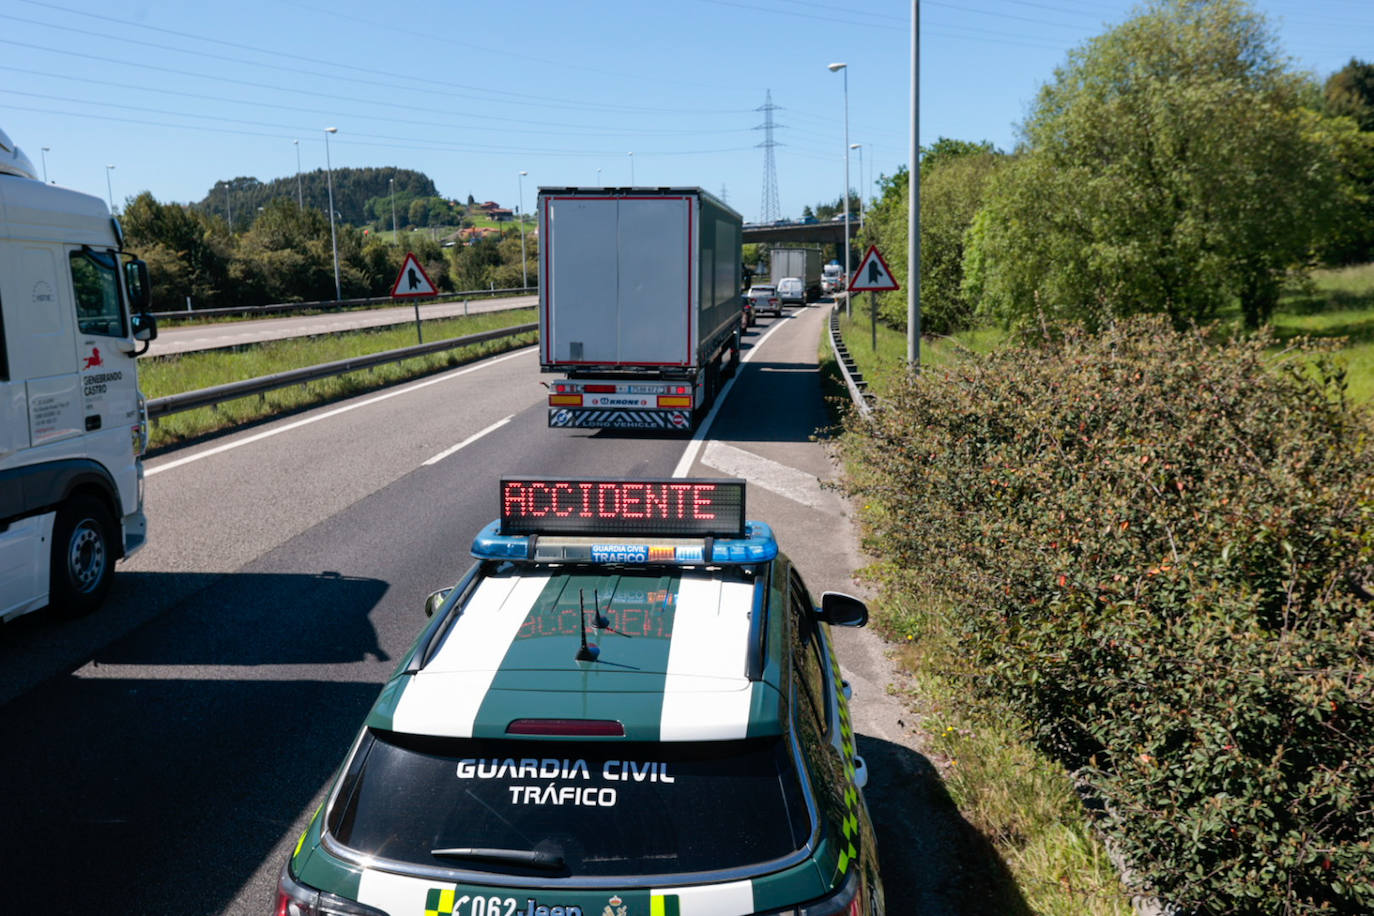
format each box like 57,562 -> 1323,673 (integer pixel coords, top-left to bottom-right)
276,478 -> 883,916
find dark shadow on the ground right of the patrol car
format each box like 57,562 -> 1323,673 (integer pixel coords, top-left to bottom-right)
856,735 -> 1033,916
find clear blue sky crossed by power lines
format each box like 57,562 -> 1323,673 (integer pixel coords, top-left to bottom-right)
0,0 -> 1374,220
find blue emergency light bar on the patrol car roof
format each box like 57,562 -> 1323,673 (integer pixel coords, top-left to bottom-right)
473,519 -> 778,566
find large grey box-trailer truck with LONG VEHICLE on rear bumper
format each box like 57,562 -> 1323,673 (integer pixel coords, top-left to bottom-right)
539,188 -> 743,431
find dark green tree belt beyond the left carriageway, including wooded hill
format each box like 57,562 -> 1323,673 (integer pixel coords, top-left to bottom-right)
120,169 -> 539,312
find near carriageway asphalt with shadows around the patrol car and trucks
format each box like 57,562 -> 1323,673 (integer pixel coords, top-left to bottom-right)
0,308 -> 1004,916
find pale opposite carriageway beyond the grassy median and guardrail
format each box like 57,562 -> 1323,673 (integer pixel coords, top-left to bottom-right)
146,295 -> 539,356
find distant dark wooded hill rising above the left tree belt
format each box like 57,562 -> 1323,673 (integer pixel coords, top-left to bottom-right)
191,166 -> 438,228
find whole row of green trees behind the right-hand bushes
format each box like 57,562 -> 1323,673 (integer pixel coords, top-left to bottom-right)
863,0 -> 1374,332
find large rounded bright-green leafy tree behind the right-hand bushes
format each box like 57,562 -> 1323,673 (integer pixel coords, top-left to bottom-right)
965,0 -> 1340,325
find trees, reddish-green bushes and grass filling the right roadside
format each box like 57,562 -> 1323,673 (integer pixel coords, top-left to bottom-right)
841,0 -> 1374,915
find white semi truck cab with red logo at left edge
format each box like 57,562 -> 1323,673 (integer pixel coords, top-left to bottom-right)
0,130 -> 157,621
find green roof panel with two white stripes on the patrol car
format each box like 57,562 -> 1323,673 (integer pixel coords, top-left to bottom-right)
368,563 -> 782,742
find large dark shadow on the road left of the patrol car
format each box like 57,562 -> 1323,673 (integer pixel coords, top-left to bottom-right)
0,573 -> 390,913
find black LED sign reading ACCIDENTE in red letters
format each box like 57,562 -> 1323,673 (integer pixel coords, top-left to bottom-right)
500,477 -> 745,537
